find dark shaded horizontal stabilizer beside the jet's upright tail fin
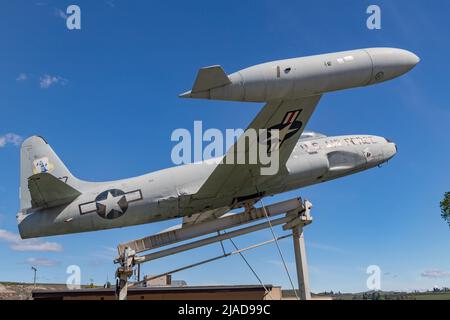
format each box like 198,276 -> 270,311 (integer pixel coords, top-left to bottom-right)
28,173 -> 81,208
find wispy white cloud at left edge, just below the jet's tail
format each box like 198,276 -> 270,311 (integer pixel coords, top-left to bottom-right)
0,229 -> 63,252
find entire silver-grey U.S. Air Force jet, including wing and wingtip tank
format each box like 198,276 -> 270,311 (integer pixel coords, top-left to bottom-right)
17,48 -> 419,238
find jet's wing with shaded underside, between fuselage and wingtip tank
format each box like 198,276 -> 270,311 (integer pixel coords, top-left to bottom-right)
192,95 -> 321,200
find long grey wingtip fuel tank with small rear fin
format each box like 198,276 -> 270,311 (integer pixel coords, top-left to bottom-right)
180,48 -> 420,102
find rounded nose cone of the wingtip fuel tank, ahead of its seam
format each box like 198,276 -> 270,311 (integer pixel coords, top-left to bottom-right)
366,48 -> 420,83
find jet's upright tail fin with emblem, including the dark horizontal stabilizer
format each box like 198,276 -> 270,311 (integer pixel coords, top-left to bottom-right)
20,136 -> 81,211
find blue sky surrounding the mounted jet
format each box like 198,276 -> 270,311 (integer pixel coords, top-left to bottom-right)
0,0 -> 450,291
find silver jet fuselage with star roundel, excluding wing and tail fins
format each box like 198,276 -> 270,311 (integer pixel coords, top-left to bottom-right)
17,135 -> 396,238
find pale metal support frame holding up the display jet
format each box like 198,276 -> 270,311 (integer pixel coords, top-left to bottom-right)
114,198 -> 312,300
